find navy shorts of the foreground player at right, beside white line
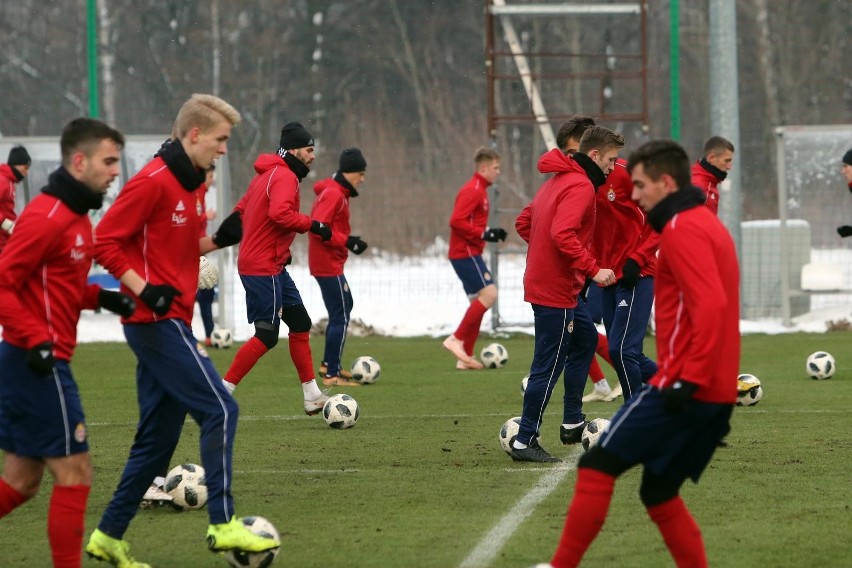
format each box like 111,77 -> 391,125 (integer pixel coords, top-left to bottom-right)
600,385 -> 734,482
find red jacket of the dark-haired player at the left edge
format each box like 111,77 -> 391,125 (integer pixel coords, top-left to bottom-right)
0,193 -> 100,361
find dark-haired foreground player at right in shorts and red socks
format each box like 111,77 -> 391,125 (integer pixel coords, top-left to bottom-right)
550,140 -> 740,568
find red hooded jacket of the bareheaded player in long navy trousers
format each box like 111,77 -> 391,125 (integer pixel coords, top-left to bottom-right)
515,148 -> 600,308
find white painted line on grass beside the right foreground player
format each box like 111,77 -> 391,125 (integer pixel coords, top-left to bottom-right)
459,448 -> 580,568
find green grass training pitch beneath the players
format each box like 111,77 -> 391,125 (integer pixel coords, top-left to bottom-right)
0,333 -> 852,568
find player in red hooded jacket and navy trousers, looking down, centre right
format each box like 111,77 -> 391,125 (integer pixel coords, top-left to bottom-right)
510,126 -> 624,462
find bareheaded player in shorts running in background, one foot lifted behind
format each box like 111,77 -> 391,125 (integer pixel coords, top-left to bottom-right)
444,148 -> 507,370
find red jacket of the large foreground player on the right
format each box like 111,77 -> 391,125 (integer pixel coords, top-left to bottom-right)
649,207 -> 740,404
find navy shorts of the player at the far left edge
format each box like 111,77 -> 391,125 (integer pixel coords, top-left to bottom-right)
0,342 -> 89,458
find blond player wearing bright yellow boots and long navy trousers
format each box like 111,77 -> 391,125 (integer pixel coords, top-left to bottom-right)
86,94 -> 279,567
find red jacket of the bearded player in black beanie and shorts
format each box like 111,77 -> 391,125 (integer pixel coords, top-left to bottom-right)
234,154 -> 311,276
